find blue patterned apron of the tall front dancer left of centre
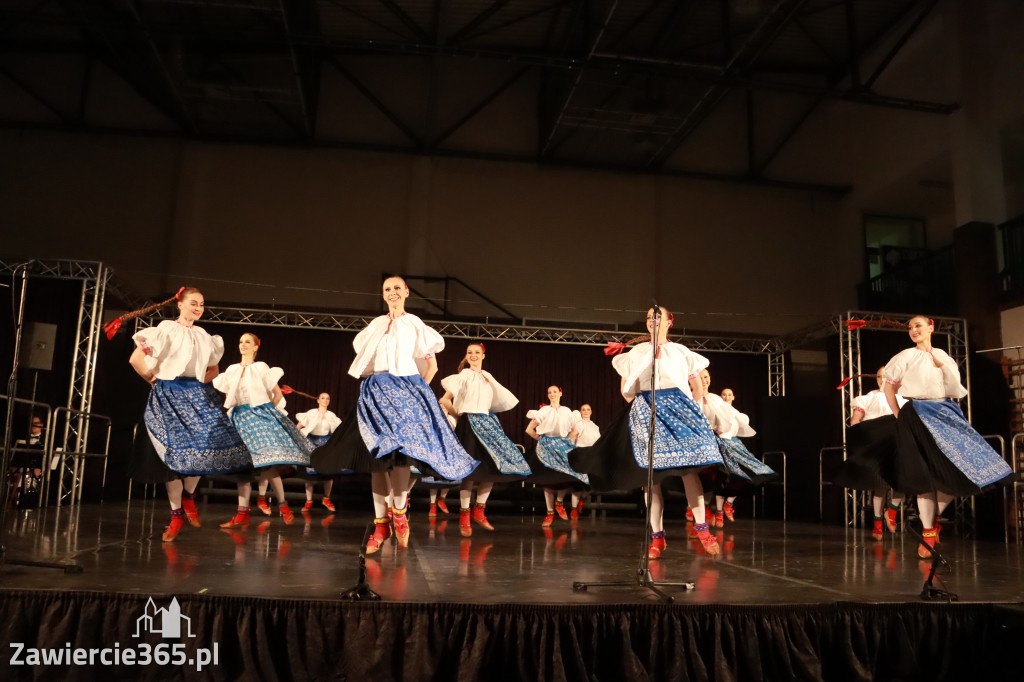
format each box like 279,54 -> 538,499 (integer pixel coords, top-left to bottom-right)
356,373 -> 479,480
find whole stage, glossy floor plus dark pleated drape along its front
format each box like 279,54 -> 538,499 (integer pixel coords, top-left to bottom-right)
0,500 -> 1024,681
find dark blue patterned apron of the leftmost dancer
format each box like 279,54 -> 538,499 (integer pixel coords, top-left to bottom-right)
143,377 -> 253,480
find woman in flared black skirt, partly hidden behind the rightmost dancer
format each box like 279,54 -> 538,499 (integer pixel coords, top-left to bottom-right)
833,367 -> 906,540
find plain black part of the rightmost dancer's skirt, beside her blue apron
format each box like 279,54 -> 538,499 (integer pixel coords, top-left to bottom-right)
892,400 -> 988,497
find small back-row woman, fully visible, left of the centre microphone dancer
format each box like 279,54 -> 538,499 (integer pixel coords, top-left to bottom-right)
526,386 -> 590,528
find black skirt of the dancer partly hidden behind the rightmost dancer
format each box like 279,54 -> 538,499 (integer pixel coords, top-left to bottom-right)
831,415 -> 902,492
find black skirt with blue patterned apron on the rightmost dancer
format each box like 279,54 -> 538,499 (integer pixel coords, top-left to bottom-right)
891,400 -> 1012,497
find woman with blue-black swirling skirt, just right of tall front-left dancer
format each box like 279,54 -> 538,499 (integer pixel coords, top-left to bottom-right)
441,343 -> 529,538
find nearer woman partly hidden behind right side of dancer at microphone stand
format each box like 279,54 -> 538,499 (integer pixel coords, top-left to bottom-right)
700,370 -> 775,528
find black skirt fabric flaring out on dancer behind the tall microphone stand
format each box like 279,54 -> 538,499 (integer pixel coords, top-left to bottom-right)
573,407 -> 703,491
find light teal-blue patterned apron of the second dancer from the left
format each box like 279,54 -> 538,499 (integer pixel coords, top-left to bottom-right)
231,402 -> 313,467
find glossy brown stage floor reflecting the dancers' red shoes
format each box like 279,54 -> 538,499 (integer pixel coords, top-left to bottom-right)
0,500 -> 1024,604
